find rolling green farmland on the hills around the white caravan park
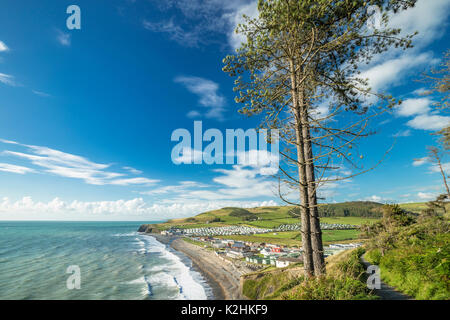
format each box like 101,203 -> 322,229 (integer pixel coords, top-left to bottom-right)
141,201 -> 440,246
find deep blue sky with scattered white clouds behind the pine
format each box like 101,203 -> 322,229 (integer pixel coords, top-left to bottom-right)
0,0 -> 450,220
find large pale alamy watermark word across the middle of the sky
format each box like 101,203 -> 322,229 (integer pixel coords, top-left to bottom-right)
171,121 -> 279,170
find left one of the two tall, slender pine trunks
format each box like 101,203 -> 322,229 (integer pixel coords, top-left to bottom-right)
290,60 -> 314,277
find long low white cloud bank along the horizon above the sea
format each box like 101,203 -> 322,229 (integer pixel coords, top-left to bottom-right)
0,197 -> 277,221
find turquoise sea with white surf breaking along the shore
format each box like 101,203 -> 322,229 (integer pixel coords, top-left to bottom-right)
0,222 -> 211,300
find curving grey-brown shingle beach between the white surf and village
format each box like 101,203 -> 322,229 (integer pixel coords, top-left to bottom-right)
143,233 -> 245,300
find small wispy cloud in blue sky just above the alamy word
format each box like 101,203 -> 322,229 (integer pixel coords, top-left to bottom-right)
174,76 -> 225,120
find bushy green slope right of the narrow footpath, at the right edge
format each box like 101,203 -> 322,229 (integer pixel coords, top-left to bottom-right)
365,205 -> 450,300
